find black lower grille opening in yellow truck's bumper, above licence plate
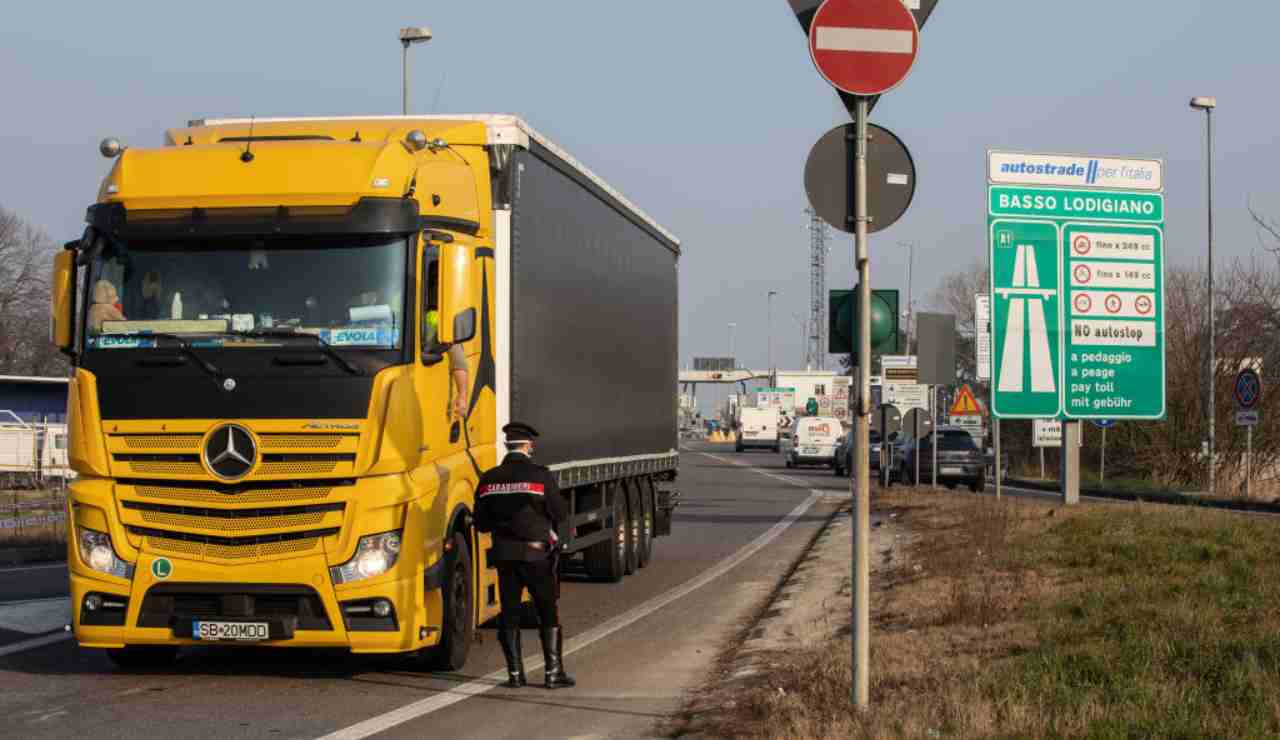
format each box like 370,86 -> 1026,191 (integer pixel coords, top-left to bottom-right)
138,584 -> 333,630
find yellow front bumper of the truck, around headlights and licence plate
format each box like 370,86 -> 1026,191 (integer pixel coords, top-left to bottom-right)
67,476 -> 443,653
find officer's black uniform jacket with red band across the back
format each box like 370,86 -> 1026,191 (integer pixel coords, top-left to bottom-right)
475,452 -> 568,559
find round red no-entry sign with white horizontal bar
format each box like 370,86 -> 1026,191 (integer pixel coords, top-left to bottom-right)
809,0 -> 920,95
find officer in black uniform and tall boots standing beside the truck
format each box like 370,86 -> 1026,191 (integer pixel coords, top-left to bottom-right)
475,421 -> 573,689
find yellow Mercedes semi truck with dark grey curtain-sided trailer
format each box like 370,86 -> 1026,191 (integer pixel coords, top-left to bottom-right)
52,115 -> 680,670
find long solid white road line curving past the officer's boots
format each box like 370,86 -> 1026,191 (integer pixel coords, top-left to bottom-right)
320,452 -> 822,740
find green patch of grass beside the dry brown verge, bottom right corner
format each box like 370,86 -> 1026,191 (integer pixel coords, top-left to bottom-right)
983,507 -> 1280,737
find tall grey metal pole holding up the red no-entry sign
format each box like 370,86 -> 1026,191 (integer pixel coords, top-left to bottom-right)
845,96 -> 872,709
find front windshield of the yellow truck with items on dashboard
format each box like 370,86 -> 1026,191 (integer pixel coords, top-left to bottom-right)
84,236 -> 408,350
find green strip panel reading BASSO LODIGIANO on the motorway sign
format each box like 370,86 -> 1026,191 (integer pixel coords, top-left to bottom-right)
988,186 -> 1165,224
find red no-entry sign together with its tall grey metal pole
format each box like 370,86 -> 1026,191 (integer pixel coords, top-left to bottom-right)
801,0 -> 920,708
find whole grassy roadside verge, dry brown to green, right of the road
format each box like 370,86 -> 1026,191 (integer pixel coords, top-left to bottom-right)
675,490 -> 1280,737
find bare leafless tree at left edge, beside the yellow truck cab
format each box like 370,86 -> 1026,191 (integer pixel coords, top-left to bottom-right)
0,206 -> 67,375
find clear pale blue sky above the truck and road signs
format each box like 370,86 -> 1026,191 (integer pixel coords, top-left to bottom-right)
0,0 -> 1280,386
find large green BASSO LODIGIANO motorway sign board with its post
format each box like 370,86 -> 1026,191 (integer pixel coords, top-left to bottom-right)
987,150 -> 1166,504
